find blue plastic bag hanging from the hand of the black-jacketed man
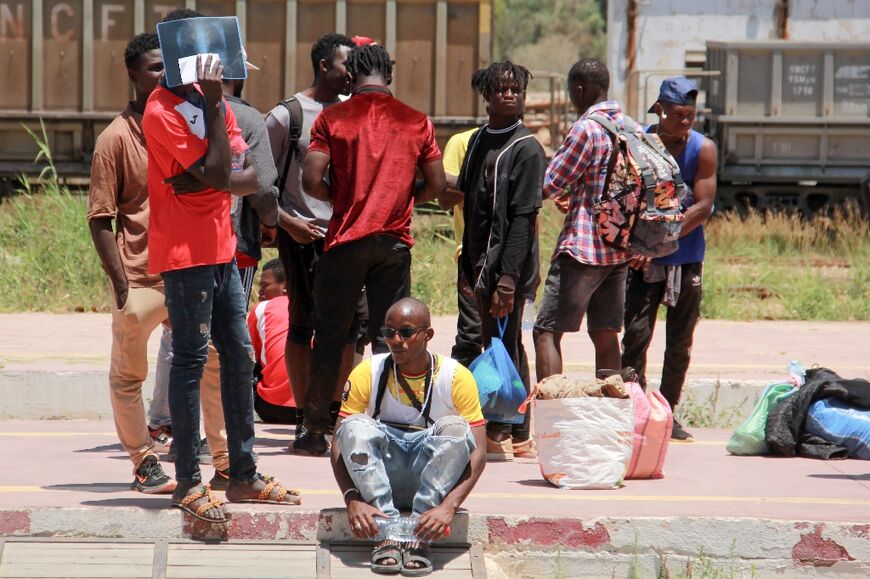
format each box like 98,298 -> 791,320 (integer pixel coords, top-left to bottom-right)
469,318 -> 527,424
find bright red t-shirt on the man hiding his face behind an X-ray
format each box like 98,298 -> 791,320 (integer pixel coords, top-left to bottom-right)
142,86 -> 247,273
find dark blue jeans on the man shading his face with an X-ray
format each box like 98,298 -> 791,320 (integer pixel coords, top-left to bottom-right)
163,261 -> 257,483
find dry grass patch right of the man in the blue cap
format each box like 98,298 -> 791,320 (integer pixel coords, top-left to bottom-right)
701,211 -> 870,321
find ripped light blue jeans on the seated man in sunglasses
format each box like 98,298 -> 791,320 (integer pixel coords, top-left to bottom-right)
335,414 -> 475,517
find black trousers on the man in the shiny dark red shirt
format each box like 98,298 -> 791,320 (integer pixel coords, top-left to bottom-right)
304,235 -> 411,434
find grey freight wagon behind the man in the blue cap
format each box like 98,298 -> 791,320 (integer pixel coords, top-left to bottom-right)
705,40 -> 870,214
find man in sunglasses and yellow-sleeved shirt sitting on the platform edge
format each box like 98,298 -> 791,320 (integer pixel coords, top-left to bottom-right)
332,298 -> 486,576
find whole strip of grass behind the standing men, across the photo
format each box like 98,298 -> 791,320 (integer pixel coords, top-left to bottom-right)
0,135 -> 870,321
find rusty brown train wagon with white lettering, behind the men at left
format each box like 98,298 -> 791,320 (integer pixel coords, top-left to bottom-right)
0,0 -> 492,194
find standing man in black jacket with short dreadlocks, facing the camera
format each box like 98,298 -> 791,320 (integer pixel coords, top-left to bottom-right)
458,62 -> 547,460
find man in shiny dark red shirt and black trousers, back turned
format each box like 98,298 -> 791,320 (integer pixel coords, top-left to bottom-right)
293,44 -> 446,455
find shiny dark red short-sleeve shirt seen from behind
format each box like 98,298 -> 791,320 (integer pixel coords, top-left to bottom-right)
308,91 -> 441,250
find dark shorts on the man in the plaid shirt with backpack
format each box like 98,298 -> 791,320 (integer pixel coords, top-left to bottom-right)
535,253 -> 628,333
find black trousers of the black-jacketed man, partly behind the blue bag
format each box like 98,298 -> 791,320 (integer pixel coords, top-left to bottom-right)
477,294 -> 532,442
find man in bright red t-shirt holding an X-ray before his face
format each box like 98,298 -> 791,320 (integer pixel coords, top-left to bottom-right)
142,13 -> 301,523
